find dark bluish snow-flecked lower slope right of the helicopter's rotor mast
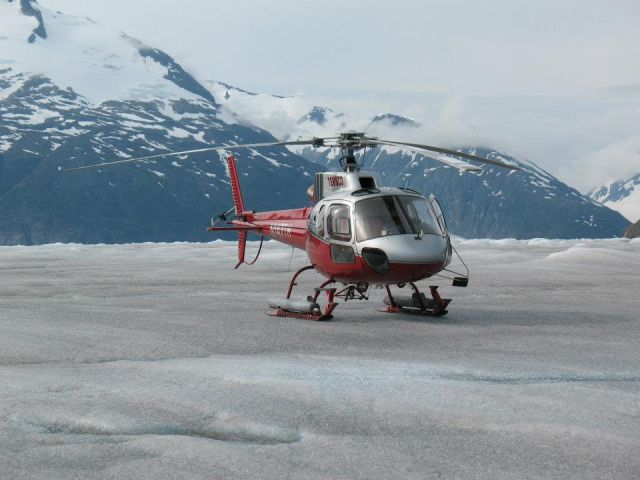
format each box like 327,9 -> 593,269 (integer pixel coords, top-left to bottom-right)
308,147 -> 629,239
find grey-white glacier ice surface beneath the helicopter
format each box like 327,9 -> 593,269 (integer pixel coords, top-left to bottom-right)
0,240 -> 640,479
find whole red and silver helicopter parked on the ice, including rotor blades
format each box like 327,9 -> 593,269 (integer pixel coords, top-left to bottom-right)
67,132 -> 519,321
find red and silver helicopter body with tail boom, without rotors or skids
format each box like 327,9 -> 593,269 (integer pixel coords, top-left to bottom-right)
238,182 -> 451,285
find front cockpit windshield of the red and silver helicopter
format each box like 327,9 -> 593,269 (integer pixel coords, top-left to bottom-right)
356,195 -> 443,242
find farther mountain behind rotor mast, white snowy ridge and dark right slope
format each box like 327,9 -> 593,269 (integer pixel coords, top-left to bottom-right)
207,82 -> 629,242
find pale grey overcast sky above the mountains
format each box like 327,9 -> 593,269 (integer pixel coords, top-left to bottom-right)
40,0 -> 640,190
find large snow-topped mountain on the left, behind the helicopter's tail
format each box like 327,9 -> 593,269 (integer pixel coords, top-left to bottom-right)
0,0 -> 318,244
